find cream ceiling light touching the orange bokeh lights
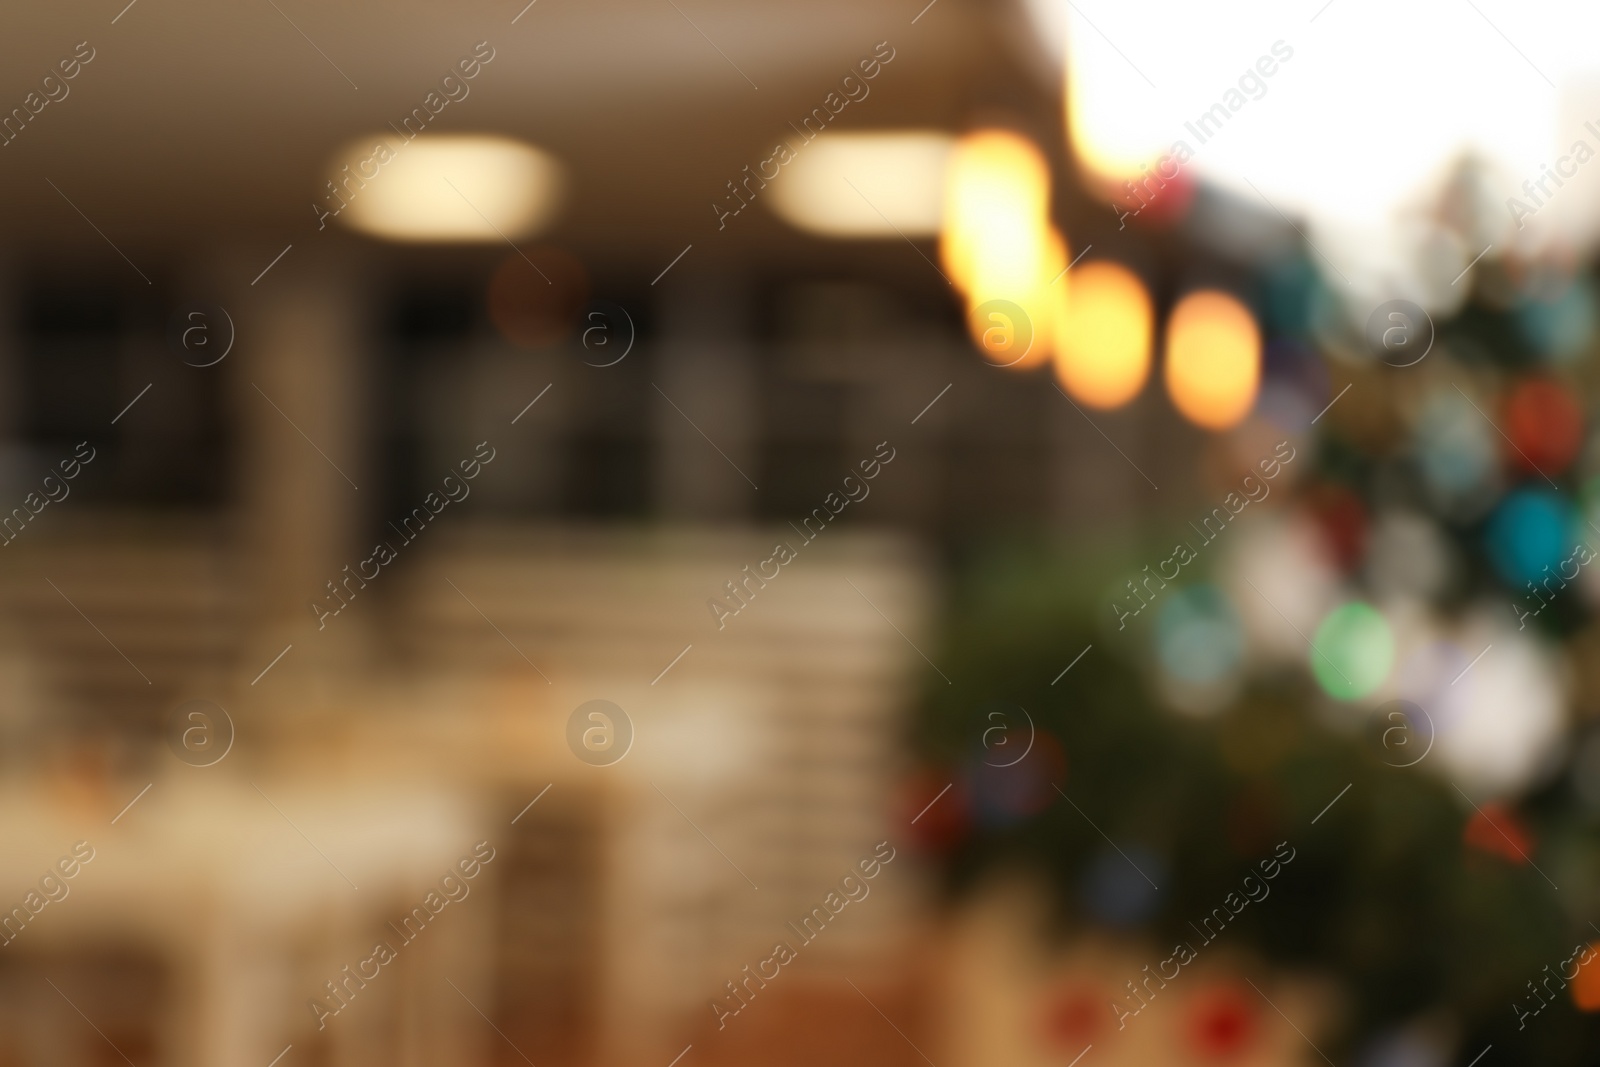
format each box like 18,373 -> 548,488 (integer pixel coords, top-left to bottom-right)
768,130 -> 955,237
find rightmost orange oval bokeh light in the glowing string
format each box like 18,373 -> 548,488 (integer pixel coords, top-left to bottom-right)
1166,290 -> 1261,430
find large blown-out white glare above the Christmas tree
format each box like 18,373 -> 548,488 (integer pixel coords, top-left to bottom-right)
1022,0 -> 1600,307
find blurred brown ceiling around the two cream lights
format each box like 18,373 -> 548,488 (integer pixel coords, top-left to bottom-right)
0,0 -> 1059,278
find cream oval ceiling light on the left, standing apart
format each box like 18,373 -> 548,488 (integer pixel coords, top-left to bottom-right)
331,134 -> 562,242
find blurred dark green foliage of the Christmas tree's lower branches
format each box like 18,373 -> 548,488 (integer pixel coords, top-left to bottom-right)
915,545 -> 1600,1064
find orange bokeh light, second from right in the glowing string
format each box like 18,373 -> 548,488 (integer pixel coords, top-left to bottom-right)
1054,261 -> 1154,408
